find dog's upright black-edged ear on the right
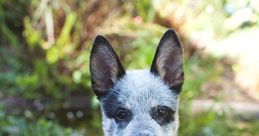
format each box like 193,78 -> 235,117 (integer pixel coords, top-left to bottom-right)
150,29 -> 184,93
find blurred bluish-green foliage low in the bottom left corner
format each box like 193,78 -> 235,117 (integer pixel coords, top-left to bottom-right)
0,110 -> 83,136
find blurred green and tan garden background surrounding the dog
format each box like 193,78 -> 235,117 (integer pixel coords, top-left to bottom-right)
0,0 -> 259,136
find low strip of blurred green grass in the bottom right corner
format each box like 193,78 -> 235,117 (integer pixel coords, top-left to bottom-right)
179,109 -> 259,136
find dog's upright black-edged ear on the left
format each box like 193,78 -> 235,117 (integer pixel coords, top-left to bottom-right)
90,36 -> 125,98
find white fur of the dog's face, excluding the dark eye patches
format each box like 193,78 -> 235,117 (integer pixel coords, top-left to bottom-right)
100,70 -> 179,136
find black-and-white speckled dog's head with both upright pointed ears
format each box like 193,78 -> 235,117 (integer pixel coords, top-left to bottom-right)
90,29 -> 184,136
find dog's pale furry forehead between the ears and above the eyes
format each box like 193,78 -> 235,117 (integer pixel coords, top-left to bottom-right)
108,70 -> 178,110
